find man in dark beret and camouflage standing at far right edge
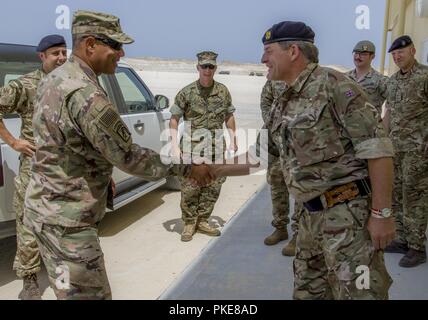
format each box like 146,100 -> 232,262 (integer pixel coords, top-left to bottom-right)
385,36 -> 428,267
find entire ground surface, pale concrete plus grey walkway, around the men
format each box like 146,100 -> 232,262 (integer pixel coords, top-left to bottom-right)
0,61 -> 428,299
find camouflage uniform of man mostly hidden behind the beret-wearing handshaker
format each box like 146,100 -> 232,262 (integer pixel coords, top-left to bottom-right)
260,80 -> 301,233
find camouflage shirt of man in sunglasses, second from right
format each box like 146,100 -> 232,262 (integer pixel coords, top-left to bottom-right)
346,68 -> 388,114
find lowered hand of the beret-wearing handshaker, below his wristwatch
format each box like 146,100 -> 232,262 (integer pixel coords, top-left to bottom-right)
367,217 -> 395,250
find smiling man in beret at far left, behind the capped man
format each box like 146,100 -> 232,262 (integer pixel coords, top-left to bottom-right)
0,35 -> 67,300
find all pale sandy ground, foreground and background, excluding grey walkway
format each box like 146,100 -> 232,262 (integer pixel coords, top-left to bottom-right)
0,61 -> 266,299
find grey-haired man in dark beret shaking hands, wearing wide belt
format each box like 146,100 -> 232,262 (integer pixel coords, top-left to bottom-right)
211,21 -> 395,299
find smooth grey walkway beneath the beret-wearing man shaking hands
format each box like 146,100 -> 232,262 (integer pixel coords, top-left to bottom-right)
160,187 -> 428,300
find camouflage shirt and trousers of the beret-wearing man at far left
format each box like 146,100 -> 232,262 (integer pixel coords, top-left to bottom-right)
0,70 -> 45,278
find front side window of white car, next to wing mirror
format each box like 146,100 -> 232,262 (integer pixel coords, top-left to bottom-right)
115,68 -> 155,113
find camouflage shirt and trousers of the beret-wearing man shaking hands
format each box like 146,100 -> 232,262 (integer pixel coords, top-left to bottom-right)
258,63 -> 393,299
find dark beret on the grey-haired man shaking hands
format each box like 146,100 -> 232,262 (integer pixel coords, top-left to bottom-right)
262,21 -> 315,44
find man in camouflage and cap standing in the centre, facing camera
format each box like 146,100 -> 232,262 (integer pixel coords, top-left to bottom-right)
170,51 -> 237,241
